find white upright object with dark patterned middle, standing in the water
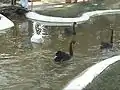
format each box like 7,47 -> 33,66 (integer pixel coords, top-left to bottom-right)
31,22 -> 46,43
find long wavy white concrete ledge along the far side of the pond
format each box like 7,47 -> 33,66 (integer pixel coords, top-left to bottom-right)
26,10 -> 120,26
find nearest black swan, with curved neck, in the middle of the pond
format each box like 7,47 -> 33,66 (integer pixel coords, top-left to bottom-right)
54,41 -> 75,62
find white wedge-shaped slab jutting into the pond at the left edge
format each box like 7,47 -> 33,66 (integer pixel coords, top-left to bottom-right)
0,14 -> 14,32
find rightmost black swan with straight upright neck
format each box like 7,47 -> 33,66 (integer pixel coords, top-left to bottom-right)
100,29 -> 113,49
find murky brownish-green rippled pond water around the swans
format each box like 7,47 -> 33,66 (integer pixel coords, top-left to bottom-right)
0,10 -> 120,90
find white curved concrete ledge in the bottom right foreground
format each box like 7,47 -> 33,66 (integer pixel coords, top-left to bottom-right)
63,55 -> 120,90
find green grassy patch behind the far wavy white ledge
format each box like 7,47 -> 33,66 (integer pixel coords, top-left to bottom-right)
37,2 -> 105,17
